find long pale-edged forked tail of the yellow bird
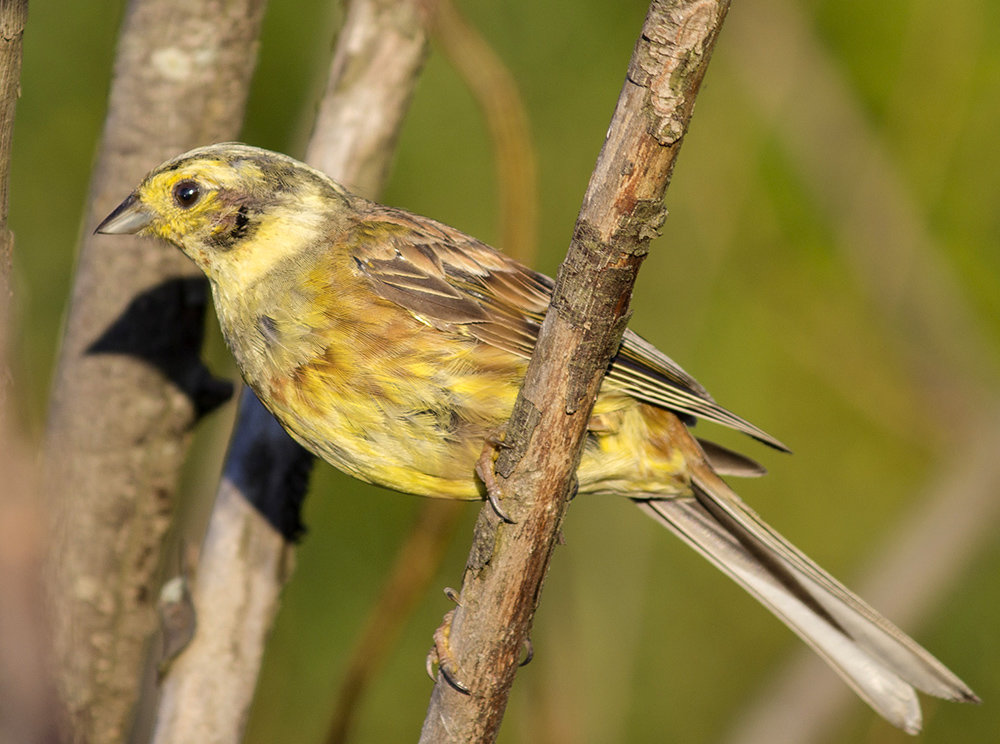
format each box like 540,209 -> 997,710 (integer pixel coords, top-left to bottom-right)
635,463 -> 978,734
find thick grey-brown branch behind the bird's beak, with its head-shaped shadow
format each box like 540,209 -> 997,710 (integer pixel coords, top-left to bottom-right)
44,0 -> 264,743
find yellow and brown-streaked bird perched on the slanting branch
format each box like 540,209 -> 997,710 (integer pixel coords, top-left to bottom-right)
95,142 -> 978,733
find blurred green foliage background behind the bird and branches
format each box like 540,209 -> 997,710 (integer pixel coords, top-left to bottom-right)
11,0 -> 1000,744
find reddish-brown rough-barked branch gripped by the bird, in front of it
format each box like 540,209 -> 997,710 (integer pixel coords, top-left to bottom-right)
421,0 -> 729,743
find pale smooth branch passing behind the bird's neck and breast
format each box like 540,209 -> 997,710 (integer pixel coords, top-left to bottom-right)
146,0 -> 426,744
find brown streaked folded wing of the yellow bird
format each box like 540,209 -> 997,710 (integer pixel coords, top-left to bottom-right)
348,205 -> 787,450
